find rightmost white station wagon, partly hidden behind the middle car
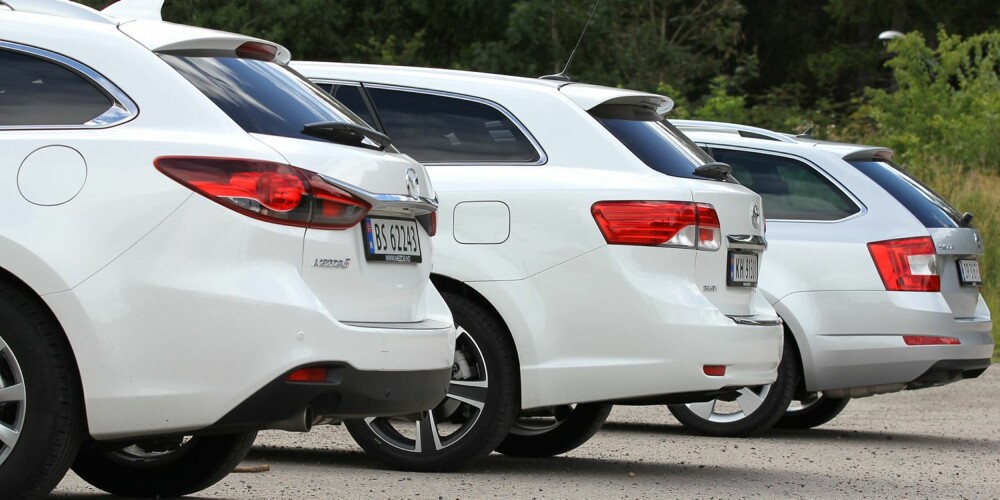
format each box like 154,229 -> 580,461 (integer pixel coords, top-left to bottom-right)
671,120 -> 993,435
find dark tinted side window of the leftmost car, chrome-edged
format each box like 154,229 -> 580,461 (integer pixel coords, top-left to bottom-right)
0,50 -> 112,126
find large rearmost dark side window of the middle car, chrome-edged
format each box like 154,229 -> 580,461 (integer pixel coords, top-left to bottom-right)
368,88 -> 541,163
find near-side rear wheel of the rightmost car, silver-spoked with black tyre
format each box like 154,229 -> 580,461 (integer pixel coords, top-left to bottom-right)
669,335 -> 799,437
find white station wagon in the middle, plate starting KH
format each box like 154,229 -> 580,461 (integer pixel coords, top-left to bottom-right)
292,62 -> 782,470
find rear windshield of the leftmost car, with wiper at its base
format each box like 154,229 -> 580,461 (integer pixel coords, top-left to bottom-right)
160,54 -> 365,142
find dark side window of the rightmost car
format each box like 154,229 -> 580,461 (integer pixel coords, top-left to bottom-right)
712,147 -> 861,220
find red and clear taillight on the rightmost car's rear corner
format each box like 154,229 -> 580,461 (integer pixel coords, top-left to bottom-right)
868,236 -> 941,292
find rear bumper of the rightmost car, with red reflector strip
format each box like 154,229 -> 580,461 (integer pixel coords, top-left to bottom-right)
775,291 -> 993,397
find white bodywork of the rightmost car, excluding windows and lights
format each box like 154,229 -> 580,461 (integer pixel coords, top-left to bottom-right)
674,120 -> 993,397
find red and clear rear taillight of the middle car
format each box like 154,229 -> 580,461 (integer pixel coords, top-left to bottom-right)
590,201 -> 722,250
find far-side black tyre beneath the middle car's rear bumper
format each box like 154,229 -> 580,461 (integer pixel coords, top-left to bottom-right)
496,403 -> 614,457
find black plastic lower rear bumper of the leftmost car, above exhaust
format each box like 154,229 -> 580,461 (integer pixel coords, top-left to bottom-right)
205,363 -> 451,432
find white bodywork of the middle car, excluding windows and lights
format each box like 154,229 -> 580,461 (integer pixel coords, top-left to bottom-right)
292,62 -> 783,408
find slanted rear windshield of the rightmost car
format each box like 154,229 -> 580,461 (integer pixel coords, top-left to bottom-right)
851,161 -> 962,228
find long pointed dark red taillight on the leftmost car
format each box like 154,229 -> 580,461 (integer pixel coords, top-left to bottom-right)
153,156 -> 371,229
